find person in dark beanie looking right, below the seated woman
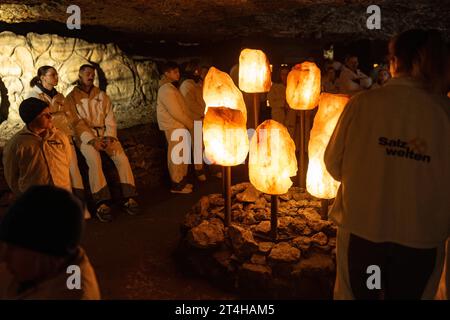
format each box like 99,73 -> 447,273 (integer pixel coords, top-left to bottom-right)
3,98 -> 72,196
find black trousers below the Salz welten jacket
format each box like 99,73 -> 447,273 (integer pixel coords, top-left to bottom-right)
348,234 -> 437,300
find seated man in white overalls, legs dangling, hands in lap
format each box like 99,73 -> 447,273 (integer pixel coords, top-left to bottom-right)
66,64 -> 139,222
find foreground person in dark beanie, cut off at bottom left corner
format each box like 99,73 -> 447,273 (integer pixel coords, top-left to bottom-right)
0,186 -> 100,300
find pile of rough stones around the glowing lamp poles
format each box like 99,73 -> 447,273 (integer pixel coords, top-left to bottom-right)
177,183 -> 336,299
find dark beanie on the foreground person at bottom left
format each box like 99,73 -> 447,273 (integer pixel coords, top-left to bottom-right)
0,186 -> 84,257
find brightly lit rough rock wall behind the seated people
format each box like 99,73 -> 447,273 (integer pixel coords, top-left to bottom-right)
0,32 -> 158,145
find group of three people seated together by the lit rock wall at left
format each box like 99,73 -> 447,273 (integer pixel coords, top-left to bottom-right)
3,64 -> 139,222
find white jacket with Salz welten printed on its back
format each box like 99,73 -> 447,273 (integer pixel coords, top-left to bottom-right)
324,78 -> 450,248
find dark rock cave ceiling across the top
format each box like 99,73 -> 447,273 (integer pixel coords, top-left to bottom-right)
0,0 -> 450,44
